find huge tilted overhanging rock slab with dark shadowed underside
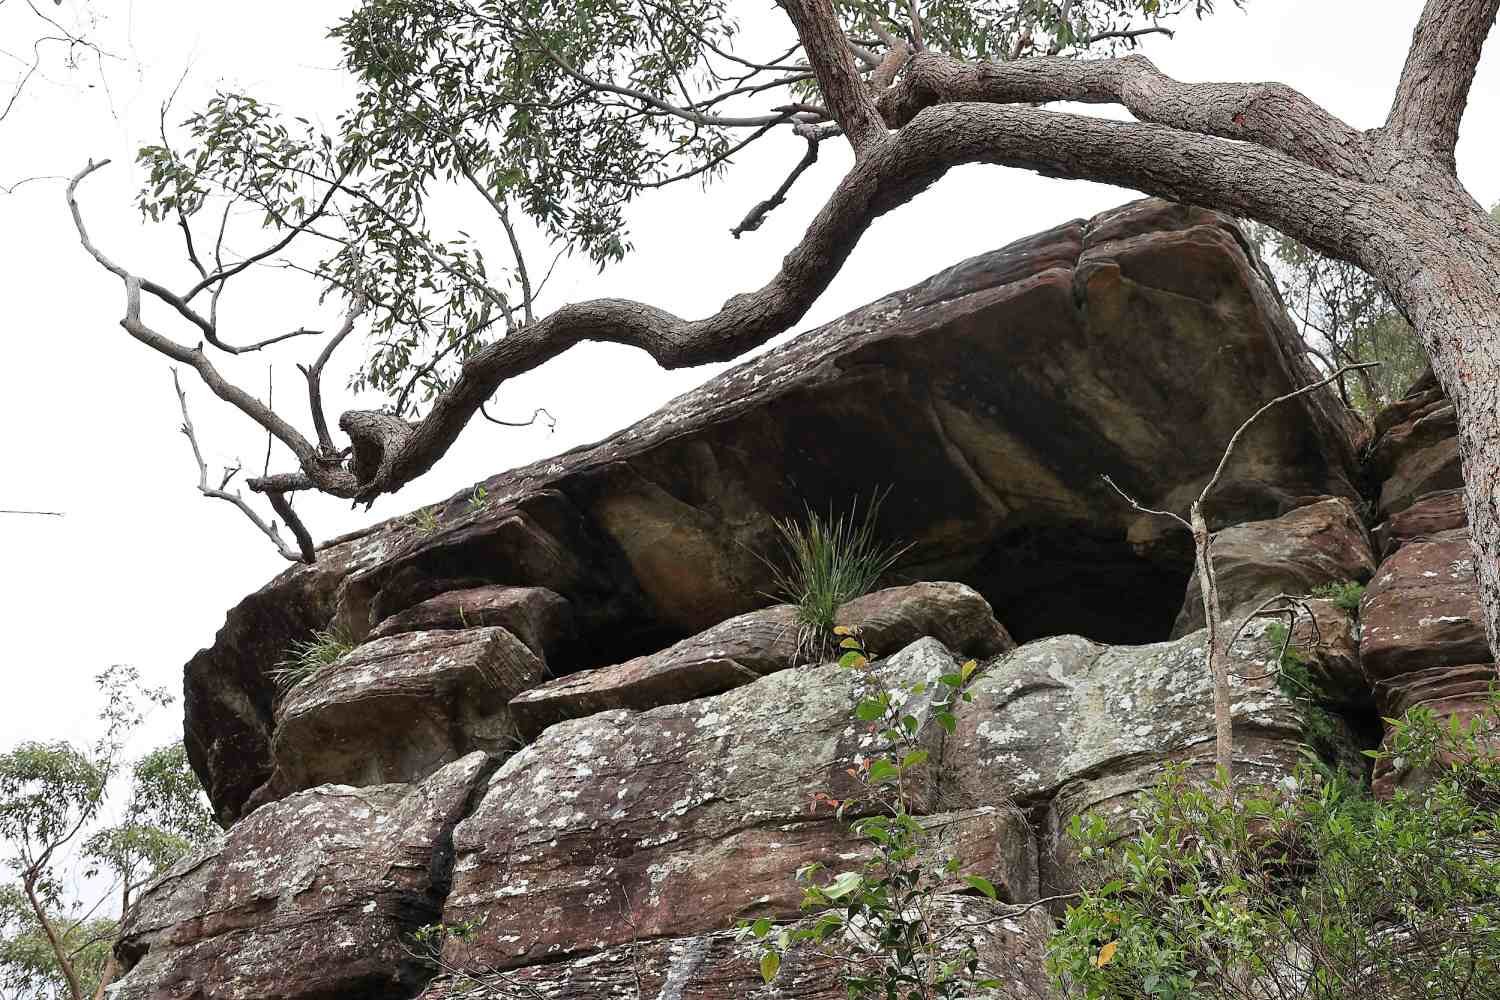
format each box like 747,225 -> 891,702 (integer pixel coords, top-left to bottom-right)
186,201 -> 1358,820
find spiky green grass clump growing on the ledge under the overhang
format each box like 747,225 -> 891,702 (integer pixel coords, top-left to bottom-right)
765,495 -> 911,645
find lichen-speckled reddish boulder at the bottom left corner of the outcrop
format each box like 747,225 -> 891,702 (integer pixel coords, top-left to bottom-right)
110,753 -> 489,1000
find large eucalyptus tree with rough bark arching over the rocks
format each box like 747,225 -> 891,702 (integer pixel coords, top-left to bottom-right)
68,0 -> 1500,659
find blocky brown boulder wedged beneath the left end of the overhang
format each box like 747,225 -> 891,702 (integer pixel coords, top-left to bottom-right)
251,628 -> 543,805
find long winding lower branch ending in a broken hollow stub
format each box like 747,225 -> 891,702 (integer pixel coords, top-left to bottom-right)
325,103 -> 1355,501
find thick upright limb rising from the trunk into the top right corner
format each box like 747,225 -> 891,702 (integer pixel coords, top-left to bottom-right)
1386,0 -> 1500,171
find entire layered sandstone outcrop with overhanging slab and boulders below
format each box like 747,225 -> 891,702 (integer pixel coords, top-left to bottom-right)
117,201 -> 1494,1000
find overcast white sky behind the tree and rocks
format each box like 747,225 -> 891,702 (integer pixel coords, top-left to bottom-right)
0,0 -> 1500,745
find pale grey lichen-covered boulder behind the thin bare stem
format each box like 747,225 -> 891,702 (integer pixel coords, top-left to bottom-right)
942,622 -> 1349,895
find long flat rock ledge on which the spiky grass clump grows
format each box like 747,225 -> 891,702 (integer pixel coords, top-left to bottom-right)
510,583 -> 1016,739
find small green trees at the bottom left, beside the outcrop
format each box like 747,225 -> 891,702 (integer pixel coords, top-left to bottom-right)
0,667 -> 218,1000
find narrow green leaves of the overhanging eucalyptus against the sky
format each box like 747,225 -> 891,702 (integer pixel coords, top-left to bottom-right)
138,0 -> 1239,417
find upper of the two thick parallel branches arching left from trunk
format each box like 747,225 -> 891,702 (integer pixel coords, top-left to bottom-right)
879,50 -> 1374,180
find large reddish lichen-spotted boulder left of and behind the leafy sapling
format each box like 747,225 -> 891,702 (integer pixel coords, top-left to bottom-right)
443,639 -> 1037,969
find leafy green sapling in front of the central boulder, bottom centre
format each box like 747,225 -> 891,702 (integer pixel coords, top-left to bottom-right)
741,627 -> 998,1000
